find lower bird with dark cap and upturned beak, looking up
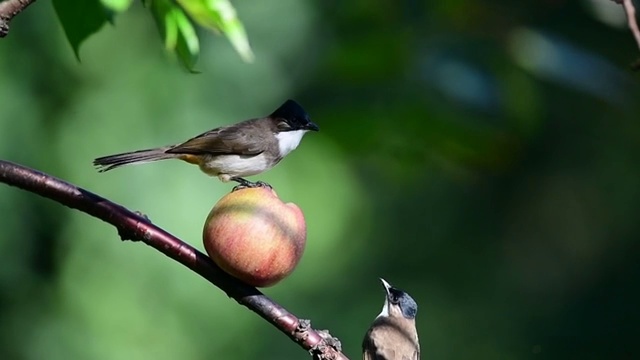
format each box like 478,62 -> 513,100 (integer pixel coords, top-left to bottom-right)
362,278 -> 420,360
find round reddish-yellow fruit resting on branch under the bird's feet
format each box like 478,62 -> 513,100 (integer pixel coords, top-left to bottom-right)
203,187 -> 307,287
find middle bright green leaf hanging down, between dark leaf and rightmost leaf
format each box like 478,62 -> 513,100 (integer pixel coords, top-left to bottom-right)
149,0 -> 200,72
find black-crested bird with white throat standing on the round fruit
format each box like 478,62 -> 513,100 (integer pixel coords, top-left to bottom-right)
93,100 -> 319,187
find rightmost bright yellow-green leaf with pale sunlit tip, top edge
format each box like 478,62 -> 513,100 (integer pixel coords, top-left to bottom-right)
177,0 -> 254,62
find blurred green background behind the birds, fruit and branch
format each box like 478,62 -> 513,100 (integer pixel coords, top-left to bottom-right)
0,0 -> 640,360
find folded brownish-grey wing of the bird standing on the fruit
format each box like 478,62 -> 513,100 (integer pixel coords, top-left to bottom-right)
166,122 -> 271,156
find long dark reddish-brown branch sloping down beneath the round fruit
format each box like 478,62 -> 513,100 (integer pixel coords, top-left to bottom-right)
0,160 -> 348,360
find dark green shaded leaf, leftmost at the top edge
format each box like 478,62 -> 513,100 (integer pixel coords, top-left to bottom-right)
53,0 -> 110,61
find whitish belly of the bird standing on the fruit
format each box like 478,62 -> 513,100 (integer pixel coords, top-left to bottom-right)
200,153 -> 277,177
